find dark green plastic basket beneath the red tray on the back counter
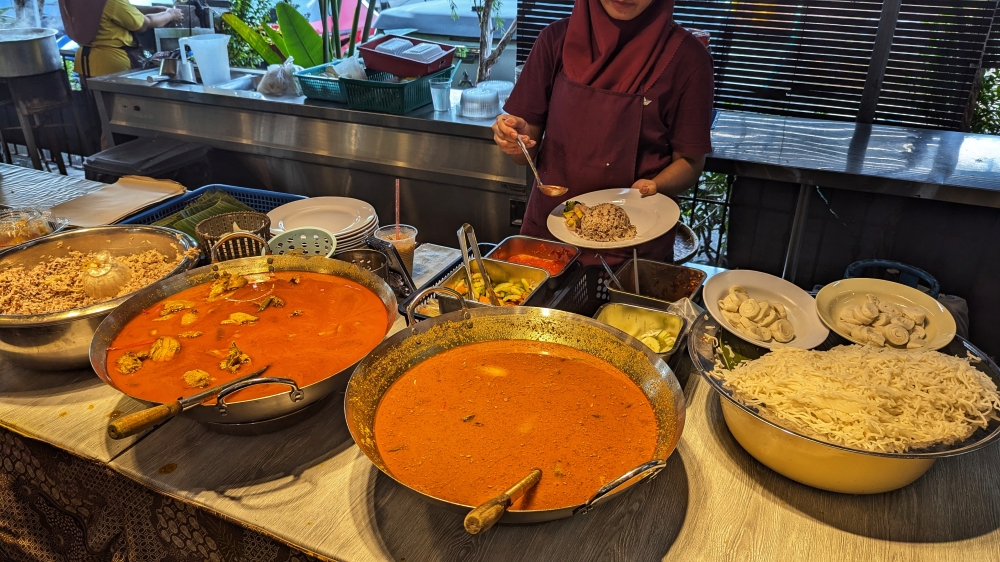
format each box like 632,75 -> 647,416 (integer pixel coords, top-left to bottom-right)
340,67 -> 454,115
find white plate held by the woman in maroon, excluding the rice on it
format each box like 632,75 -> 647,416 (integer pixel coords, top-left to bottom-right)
546,189 -> 681,250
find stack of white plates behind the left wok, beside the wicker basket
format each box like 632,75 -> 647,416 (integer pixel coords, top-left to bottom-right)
267,197 -> 378,252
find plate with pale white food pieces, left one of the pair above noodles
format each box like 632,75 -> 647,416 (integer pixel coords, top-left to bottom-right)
702,269 -> 830,349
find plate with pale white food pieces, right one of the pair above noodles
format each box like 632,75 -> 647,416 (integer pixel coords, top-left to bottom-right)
816,278 -> 956,350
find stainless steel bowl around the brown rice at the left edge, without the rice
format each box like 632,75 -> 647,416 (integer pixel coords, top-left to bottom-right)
0,226 -> 198,370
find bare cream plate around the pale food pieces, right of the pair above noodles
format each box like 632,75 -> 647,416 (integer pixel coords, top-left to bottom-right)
816,277 -> 956,351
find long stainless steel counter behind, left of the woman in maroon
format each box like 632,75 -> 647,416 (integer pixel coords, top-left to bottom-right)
89,70 -> 526,245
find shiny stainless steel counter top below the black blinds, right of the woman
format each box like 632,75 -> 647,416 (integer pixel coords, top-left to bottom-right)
706,111 -> 1000,207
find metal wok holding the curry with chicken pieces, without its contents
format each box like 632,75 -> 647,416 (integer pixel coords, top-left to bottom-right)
90,252 -> 396,424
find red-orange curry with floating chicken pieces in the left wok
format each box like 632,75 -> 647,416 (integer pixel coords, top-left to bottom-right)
107,271 -> 390,402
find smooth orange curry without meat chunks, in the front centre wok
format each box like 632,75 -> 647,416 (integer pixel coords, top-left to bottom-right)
375,340 -> 658,510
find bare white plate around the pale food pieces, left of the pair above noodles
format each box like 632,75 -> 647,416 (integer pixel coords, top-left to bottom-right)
702,269 -> 830,349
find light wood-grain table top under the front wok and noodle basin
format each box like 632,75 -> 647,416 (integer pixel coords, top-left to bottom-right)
105,360 -> 1000,562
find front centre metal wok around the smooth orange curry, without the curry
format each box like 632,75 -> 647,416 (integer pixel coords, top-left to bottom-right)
344,287 -> 684,524
